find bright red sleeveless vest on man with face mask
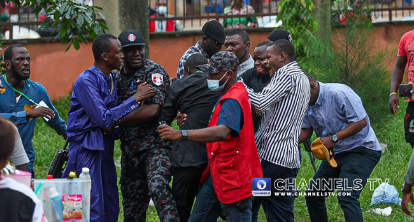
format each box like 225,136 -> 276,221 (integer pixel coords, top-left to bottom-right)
201,82 -> 263,204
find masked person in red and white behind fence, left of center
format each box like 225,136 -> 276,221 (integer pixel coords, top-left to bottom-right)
149,0 -> 182,32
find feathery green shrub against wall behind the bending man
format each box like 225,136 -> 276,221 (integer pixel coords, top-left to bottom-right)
307,17 -> 390,121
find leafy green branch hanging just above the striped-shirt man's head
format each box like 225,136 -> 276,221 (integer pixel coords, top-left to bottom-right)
276,0 -> 318,68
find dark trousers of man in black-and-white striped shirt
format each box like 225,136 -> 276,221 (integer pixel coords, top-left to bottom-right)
252,160 -> 299,222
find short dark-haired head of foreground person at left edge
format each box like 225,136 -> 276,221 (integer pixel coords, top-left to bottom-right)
0,117 -> 16,161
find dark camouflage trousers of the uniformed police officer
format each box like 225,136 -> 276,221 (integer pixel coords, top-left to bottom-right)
120,149 -> 180,222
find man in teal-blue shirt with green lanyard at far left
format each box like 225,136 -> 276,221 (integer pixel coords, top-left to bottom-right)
0,44 -> 66,177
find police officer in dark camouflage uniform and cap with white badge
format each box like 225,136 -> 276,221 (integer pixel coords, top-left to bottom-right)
117,29 -> 179,222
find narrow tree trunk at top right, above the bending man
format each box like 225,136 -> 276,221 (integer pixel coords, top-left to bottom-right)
314,0 -> 332,45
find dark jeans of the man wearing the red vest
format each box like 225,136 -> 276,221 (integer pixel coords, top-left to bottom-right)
189,176 -> 252,222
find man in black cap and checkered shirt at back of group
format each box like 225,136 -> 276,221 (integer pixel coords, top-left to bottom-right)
177,20 -> 226,79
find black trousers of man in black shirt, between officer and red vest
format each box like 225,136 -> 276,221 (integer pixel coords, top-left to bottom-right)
172,166 -> 205,222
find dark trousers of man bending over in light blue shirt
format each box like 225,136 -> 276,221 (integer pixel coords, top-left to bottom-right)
306,147 -> 381,222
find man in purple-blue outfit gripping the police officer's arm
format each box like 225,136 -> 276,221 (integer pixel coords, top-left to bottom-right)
63,34 -> 155,222
